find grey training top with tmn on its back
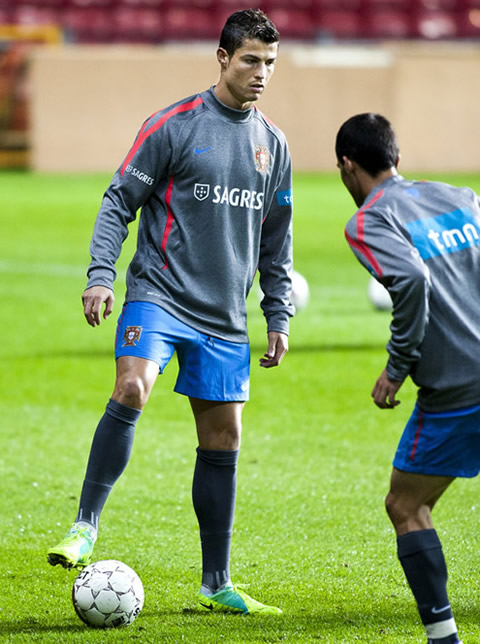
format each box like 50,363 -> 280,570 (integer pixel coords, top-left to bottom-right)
345,176 -> 480,412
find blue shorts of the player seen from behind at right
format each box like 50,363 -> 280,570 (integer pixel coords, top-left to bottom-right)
393,405 -> 480,478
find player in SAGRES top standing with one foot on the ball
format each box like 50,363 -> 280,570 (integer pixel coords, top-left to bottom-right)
48,9 -> 294,614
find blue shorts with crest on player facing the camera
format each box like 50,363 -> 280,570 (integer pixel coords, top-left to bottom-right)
115,302 -> 250,401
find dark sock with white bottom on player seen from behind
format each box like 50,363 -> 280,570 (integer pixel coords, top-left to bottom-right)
397,530 -> 457,643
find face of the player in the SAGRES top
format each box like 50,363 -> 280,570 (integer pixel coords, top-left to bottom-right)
215,39 -> 278,110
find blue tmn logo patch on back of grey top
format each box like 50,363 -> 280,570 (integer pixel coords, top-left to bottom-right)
406,208 -> 480,259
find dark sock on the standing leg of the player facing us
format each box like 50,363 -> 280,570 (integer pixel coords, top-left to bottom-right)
192,448 -> 239,592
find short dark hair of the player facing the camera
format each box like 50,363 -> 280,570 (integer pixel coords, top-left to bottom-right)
218,9 -> 280,56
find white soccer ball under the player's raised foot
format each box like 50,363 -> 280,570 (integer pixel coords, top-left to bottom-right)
72,559 -> 144,628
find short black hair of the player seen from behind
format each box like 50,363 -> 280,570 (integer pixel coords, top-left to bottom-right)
335,112 -> 399,177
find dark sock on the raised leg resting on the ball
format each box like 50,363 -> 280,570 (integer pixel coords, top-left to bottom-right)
76,399 -> 142,532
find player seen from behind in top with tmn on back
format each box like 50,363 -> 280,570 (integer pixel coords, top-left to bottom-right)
336,113 -> 480,644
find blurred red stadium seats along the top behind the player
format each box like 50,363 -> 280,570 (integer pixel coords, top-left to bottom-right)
0,0 -> 480,44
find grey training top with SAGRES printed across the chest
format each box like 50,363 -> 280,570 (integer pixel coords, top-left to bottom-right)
87,88 -> 294,342
